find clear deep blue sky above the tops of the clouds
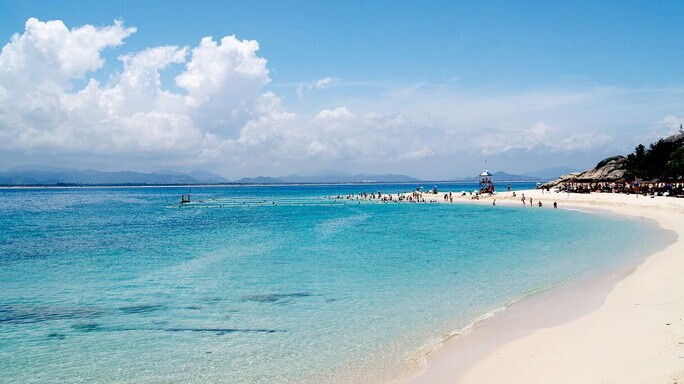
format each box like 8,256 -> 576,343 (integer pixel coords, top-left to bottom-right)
6,1 -> 684,88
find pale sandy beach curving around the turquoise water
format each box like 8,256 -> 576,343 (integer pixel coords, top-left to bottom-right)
401,190 -> 684,384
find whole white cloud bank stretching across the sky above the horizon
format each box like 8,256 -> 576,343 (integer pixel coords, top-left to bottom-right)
0,18 -> 682,177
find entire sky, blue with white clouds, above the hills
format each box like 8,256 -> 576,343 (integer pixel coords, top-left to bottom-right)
0,0 -> 684,180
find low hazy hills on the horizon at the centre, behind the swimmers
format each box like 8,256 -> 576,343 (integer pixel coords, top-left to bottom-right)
235,173 -> 420,184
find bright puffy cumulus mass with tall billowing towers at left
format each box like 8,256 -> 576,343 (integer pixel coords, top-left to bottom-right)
0,18 -> 277,160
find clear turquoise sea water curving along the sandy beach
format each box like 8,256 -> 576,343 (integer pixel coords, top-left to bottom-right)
0,185 -> 665,383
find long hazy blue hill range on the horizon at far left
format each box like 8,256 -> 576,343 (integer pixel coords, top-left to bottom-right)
0,167 -> 225,185
